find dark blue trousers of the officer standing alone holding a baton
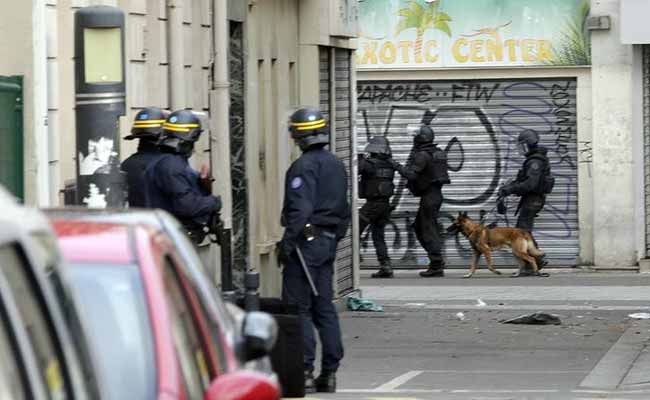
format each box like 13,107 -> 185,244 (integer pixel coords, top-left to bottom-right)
282,235 -> 343,372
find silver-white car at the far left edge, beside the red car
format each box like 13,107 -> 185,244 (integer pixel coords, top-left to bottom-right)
0,187 -> 98,400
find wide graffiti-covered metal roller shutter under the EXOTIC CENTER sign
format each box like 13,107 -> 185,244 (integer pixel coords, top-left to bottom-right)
357,78 -> 579,268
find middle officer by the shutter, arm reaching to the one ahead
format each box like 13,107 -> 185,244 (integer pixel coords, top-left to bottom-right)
393,126 -> 450,278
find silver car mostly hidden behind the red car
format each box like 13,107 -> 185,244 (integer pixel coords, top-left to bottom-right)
44,207 -> 276,379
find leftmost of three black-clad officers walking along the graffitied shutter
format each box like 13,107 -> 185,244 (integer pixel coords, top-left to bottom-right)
358,136 -> 395,278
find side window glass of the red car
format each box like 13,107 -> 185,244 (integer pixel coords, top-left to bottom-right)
164,258 -> 211,400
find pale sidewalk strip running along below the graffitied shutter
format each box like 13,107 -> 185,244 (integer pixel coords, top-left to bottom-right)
361,269 -> 650,310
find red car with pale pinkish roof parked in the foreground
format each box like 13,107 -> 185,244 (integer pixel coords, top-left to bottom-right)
53,219 -> 280,400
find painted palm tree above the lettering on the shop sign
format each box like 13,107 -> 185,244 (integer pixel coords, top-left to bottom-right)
396,0 -> 451,58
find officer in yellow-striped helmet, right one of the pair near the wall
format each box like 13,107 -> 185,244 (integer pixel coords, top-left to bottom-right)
145,110 -> 221,243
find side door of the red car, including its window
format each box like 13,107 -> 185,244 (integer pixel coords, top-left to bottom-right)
161,254 -> 222,400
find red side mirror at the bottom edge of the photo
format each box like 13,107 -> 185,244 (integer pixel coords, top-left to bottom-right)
203,370 -> 280,400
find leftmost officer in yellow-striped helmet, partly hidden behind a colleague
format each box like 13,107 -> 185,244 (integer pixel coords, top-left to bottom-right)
122,107 -> 169,207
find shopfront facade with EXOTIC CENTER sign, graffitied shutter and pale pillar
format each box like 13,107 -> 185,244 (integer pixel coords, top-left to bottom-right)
357,0 -> 648,268
